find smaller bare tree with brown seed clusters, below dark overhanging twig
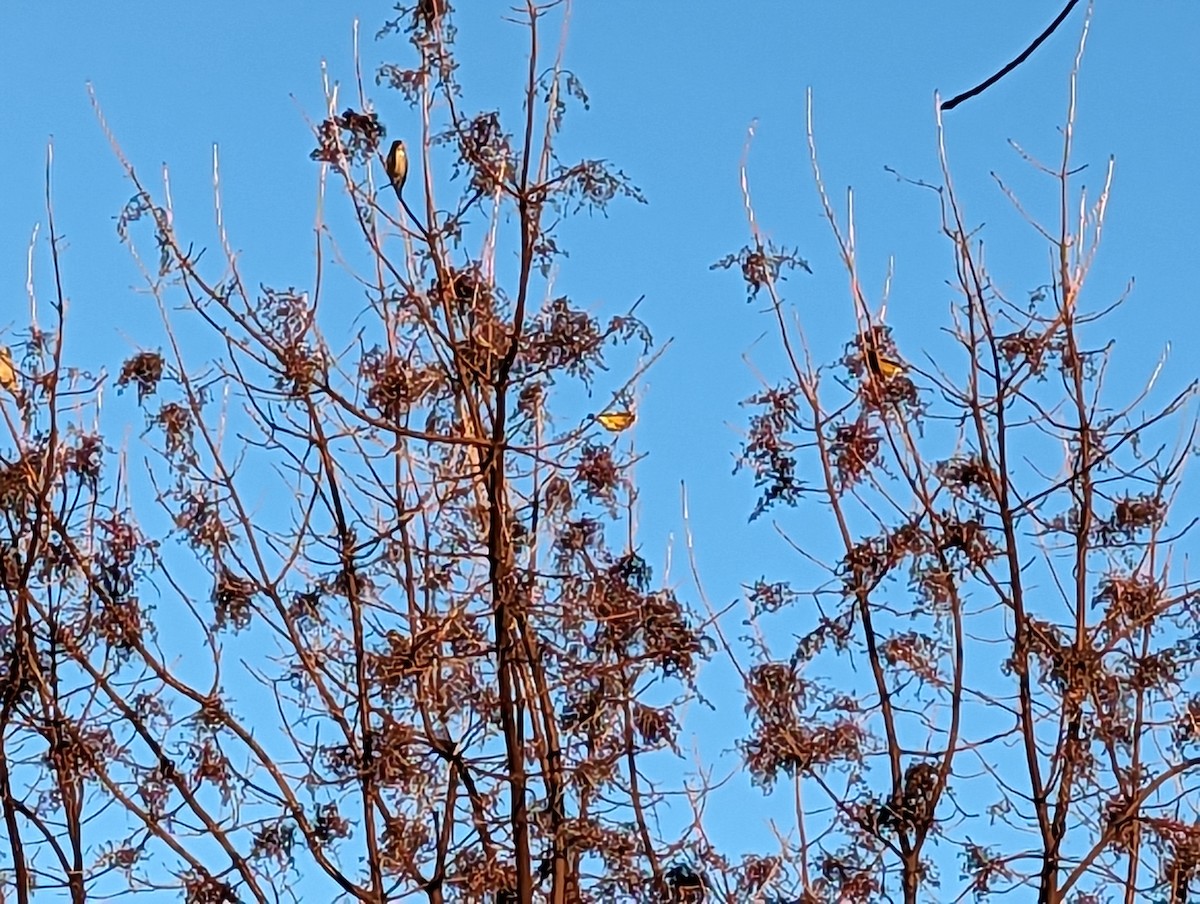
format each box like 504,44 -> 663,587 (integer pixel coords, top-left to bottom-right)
719,12 -> 1200,903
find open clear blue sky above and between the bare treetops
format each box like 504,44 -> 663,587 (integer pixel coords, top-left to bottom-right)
0,0 -> 1200,893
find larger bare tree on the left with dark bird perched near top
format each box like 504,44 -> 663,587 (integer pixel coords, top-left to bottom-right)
0,0 -> 702,902
